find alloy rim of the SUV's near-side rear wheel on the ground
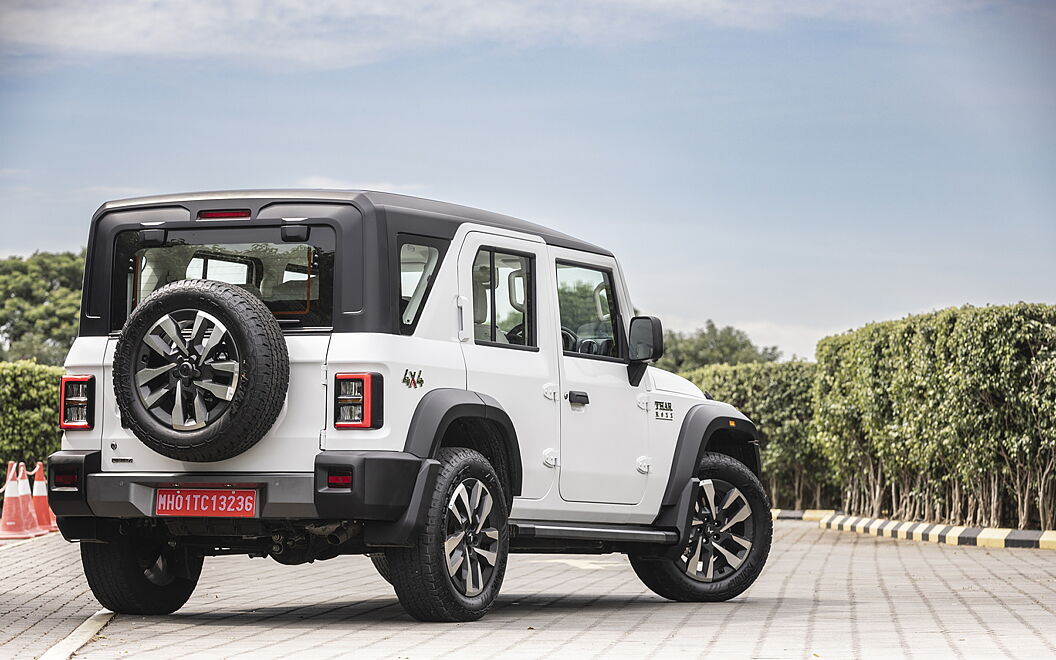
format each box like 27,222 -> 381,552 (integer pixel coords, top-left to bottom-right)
444,478 -> 498,597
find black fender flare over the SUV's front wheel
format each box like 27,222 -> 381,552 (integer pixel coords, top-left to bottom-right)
654,403 -> 761,538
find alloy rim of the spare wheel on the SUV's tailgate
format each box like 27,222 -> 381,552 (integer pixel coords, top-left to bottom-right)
133,309 -> 239,431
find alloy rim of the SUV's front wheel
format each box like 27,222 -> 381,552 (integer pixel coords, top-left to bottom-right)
680,479 -> 755,582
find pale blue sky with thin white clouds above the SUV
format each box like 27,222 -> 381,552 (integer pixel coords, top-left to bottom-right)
0,0 -> 1056,357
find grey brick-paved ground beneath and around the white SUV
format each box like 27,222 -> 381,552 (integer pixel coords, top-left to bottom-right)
0,521 -> 1056,660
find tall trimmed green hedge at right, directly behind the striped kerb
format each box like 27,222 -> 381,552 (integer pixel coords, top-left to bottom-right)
812,303 -> 1056,529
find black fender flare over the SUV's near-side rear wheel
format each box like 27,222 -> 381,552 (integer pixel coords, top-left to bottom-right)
403,388 -> 523,494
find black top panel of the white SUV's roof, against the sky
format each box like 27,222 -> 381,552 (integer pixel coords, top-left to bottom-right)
95,188 -> 611,256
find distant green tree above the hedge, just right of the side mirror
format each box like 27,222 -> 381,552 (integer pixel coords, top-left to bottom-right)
657,319 -> 781,373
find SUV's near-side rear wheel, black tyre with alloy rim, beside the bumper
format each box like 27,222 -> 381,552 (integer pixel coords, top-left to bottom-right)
385,447 -> 509,621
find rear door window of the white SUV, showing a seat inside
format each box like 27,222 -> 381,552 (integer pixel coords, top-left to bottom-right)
472,248 -> 538,347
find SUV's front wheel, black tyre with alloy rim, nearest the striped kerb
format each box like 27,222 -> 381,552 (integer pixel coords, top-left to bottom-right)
630,453 -> 774,602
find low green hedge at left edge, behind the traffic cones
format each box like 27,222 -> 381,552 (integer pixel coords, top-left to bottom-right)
0,360 -> 62,470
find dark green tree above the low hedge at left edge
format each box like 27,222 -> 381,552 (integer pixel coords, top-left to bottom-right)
0,251 -> 84,364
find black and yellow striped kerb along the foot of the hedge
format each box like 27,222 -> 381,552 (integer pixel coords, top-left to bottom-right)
817,513 -> 1056,550
